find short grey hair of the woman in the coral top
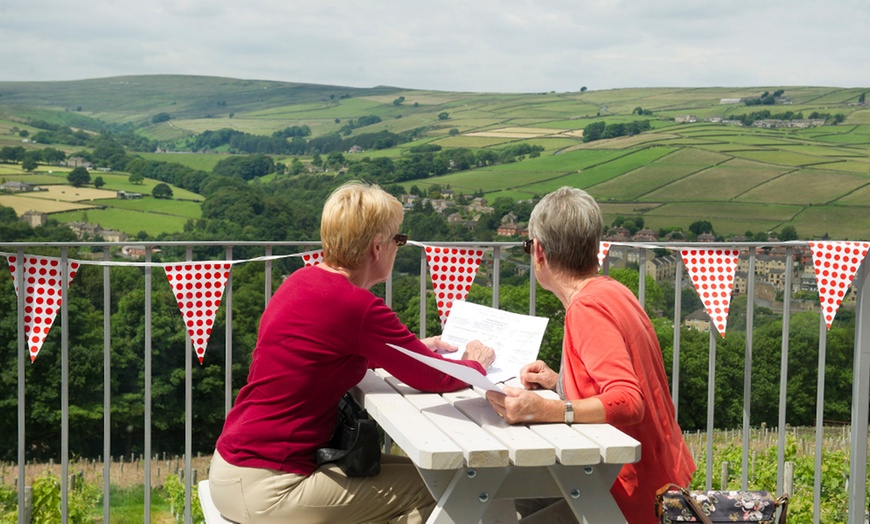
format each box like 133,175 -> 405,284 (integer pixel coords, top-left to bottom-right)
529,186 -> 604,275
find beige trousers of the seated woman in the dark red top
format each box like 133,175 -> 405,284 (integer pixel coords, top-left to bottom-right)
208,451 -> 435,524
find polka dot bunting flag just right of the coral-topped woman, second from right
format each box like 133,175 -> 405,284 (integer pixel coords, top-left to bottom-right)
680,249 -> 739,337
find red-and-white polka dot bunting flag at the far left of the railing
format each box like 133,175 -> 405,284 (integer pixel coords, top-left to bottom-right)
6,255 -> 79,362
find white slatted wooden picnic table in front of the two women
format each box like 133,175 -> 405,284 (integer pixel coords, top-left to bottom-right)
351,369 -> 641,524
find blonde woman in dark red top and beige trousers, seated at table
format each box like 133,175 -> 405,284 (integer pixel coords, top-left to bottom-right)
209,183 -> 495,524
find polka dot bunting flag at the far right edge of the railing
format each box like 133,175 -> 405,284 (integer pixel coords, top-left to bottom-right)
810,241 -> 870,329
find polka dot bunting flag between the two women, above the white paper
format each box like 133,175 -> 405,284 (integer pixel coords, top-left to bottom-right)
425,246 -> 483,326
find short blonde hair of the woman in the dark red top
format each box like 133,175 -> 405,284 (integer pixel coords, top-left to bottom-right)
320,181 -> 404,269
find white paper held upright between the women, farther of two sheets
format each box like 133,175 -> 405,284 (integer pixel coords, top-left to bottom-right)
441,300 -> 550,382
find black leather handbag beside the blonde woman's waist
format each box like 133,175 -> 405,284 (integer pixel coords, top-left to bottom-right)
315,393 -> 381,477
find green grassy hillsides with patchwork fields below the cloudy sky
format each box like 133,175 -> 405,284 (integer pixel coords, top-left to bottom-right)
0,75 -> 870,239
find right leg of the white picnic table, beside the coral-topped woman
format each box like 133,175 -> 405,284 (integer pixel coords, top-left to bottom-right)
548,464 -> 625,524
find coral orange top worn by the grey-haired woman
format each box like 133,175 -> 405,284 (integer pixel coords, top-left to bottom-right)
561,277 -> 695,524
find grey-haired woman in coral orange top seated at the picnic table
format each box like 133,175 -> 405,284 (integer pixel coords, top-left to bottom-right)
487,187 -> 695,524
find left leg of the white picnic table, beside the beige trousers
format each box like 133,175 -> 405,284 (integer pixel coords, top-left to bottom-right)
421,468 -> 508,524
